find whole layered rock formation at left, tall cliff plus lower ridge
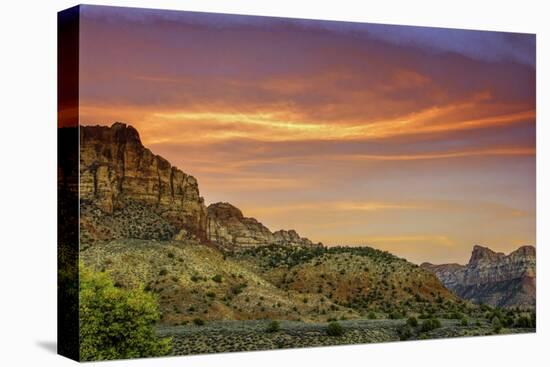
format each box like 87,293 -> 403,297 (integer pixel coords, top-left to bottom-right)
80,122 -> 326,249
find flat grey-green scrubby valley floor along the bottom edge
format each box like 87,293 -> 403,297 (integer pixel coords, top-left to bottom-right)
157,319 -> 535,355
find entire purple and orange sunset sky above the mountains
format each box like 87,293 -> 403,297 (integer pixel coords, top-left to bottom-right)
75,6 -> 536,263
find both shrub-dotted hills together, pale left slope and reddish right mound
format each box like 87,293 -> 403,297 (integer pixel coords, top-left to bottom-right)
81,240 -> 474,325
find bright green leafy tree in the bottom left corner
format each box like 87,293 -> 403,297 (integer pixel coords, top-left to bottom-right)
79,263 -> 172,361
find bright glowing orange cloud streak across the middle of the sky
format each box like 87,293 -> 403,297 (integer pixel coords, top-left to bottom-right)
86,106 -> 535,144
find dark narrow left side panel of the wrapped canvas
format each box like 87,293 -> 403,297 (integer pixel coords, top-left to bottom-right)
57,7 -> 79,360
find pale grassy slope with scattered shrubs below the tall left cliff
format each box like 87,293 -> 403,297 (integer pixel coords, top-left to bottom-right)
81,240 -> 356,324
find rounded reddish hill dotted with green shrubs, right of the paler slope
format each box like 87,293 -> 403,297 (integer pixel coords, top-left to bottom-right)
237,246 -> 465,316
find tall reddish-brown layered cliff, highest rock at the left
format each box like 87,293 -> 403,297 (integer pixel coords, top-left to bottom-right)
80,123 -> 206,240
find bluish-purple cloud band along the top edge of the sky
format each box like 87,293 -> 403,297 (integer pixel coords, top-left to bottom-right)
82,5 -> 536,68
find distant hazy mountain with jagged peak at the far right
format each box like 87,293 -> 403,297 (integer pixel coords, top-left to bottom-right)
421,245 -> 536,308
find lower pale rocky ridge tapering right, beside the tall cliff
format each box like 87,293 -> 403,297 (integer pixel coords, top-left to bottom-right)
207,203 -> 320,250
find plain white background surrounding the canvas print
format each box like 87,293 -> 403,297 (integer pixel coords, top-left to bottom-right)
0,0 -> 550,367
